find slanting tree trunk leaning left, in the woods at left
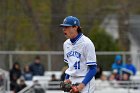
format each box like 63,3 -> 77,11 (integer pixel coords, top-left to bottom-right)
20,0 -> 45,51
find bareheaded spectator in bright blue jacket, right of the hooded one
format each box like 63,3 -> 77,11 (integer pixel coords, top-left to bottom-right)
124,59 -> 137,75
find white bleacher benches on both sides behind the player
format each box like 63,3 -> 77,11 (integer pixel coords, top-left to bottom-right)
22,71 -> 140,93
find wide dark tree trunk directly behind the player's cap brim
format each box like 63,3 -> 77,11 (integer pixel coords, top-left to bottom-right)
49,0 -> 67,51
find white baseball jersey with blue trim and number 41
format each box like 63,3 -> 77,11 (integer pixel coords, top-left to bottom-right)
63,34 -> 97,76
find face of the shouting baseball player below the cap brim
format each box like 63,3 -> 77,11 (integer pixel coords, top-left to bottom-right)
63,26 -> 78,39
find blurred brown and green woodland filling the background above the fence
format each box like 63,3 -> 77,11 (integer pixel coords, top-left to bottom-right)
0,0 -> 140,69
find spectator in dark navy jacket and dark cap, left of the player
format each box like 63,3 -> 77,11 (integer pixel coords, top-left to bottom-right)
29,56 -> 44,76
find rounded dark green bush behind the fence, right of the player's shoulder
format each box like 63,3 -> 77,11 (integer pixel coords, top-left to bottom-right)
89,26 -> 120,70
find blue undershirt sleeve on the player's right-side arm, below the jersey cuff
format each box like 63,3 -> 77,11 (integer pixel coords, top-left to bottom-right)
82,65 -> 97,85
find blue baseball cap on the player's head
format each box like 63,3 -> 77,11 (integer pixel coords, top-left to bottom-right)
60,16 -> 80,27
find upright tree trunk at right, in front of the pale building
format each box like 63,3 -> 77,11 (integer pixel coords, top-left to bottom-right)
118,0 -> 130,51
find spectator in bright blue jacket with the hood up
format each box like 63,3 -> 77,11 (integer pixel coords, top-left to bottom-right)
112,55 -> 124,75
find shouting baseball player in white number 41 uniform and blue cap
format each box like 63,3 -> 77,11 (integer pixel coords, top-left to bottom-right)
60,16 -> 97,93
